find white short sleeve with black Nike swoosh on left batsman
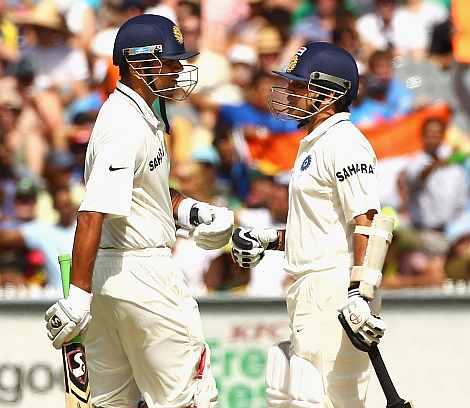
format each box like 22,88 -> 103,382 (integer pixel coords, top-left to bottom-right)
79,137 -> 138,217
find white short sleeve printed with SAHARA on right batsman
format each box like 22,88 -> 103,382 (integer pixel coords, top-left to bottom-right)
333,140 -> 380,223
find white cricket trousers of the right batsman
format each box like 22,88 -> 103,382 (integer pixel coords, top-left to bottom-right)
286,268 -> 380,408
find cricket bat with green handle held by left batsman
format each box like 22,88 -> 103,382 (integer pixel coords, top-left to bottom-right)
59,255 -> 91,408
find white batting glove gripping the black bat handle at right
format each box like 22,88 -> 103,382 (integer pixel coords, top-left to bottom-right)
339,288 -> 386,351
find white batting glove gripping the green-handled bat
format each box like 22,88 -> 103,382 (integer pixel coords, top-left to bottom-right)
44,285 -> 92,349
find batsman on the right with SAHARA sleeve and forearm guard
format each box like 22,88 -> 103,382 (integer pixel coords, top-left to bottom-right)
232,42 -> 393,408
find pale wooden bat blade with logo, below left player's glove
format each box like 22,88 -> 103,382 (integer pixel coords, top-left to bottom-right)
62,342 -> 91,408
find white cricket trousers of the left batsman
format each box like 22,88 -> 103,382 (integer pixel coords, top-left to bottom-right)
84,248 -> 216,408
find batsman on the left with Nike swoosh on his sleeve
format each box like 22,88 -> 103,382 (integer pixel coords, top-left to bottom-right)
45,14 -> 233,408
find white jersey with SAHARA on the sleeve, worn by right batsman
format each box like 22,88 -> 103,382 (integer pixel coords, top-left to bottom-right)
286,112 -> 380,275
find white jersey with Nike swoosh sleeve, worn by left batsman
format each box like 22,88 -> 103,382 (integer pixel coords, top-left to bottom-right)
79,82 -> 175,249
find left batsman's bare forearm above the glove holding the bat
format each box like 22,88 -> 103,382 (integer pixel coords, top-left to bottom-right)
71,211 -> 104,292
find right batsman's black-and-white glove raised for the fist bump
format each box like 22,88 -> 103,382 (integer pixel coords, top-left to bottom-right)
232,228 -> 279,268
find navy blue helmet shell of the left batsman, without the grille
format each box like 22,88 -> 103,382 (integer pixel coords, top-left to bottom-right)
113,14 -> 198,66
